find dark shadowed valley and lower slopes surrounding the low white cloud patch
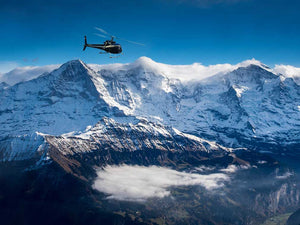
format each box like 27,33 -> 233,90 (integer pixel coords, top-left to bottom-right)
0,142 -> 299,224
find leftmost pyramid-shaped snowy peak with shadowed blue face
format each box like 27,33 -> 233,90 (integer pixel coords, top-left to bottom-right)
0,60 -> 110,137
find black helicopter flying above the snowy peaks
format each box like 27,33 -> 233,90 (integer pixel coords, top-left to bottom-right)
83,27 -> 144,58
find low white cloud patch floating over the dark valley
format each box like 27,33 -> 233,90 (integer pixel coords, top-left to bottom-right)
93,165 -> 229,201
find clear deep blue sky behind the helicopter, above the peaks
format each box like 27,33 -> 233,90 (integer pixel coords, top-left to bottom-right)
0,0 -> 300,72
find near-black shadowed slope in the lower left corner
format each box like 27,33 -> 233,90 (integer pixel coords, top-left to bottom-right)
0,165 -> 144,225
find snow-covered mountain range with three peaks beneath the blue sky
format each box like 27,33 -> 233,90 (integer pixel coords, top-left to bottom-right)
0,57 -> 300,161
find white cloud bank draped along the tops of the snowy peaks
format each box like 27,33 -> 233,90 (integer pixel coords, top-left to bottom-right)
0,57 -> 300,85
